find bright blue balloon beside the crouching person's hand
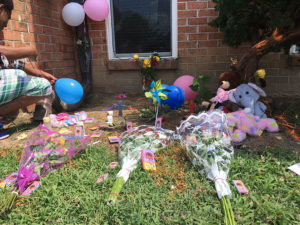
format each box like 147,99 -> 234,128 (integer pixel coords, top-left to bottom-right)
55,78 -> 83,104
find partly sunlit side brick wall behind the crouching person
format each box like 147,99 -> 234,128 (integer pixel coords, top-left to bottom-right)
0,0 -> 80,79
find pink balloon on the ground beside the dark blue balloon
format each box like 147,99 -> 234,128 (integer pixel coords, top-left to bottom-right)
173,75 -> 198,101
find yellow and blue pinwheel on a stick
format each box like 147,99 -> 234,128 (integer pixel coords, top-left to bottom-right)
145,80 -> 168,124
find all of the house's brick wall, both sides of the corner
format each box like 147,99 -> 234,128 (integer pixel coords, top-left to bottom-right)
0,0 -> 300,95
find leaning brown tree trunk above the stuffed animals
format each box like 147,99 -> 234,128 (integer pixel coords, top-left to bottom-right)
232,28 -> 300,83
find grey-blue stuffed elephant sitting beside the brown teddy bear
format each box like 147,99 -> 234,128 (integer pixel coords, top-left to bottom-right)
228,83 -> 267,118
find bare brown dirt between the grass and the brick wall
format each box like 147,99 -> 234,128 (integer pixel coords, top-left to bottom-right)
0,94 -> 300,155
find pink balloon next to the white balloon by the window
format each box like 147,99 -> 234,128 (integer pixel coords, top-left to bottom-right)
83,0 -> 109,21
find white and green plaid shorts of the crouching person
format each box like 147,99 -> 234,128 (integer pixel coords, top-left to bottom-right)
0,69 -> 52,105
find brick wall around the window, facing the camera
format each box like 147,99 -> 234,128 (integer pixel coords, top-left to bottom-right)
85,0 -> 300,95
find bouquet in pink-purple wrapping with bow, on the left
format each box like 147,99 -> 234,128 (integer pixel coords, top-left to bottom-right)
1,125 -> 89,213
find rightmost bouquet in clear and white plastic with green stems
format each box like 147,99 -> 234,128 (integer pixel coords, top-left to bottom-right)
177,111 -> 235,225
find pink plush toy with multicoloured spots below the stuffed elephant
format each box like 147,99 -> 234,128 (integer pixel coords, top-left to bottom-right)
227,110 -> 279,142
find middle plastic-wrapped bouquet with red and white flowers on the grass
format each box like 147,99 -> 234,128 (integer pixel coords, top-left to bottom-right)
108,125 -> 174,204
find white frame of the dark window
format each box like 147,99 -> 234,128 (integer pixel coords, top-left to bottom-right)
106,0 -> 178,60
